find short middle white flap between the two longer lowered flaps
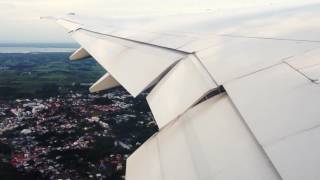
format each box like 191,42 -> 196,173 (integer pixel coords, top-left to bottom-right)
147,55 -> 217,128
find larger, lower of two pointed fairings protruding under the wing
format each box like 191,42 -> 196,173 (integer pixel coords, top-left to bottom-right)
89,73 -> 120,93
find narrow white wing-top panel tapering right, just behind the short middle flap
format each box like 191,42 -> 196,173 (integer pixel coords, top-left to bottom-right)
197,38 -> 320,85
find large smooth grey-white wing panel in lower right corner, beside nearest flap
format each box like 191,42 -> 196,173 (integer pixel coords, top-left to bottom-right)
225,63 -> 320,180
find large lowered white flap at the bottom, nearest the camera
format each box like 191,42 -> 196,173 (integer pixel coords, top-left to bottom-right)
126,94 -> 281,180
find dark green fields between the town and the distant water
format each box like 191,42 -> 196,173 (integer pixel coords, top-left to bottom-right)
0,53 -> 105,99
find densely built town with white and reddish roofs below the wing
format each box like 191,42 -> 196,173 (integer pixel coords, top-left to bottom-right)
0,85 -> 157,180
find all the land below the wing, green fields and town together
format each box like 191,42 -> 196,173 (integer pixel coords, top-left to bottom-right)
0,53 -> 157,180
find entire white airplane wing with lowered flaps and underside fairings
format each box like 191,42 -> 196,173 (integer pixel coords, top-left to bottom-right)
48,3 -> 320,180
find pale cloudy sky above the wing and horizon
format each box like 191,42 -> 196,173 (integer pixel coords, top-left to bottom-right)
0,0 -> 318,43
